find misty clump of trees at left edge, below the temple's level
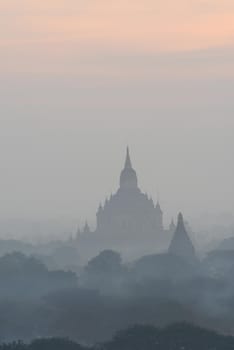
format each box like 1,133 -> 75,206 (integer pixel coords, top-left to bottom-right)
0,252 -> 77,302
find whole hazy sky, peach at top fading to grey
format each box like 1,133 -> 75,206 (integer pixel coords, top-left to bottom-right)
0,0 -> 234,235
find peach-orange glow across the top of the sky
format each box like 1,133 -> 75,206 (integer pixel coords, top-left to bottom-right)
0,0 -> 234,72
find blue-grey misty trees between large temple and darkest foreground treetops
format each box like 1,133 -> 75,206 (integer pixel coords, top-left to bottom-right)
0,250 -> 234,343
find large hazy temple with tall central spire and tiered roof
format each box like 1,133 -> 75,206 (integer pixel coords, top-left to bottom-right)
77,148 -> 174,256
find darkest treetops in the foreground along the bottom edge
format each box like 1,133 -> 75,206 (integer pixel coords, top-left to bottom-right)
0,324 -> 234,350
